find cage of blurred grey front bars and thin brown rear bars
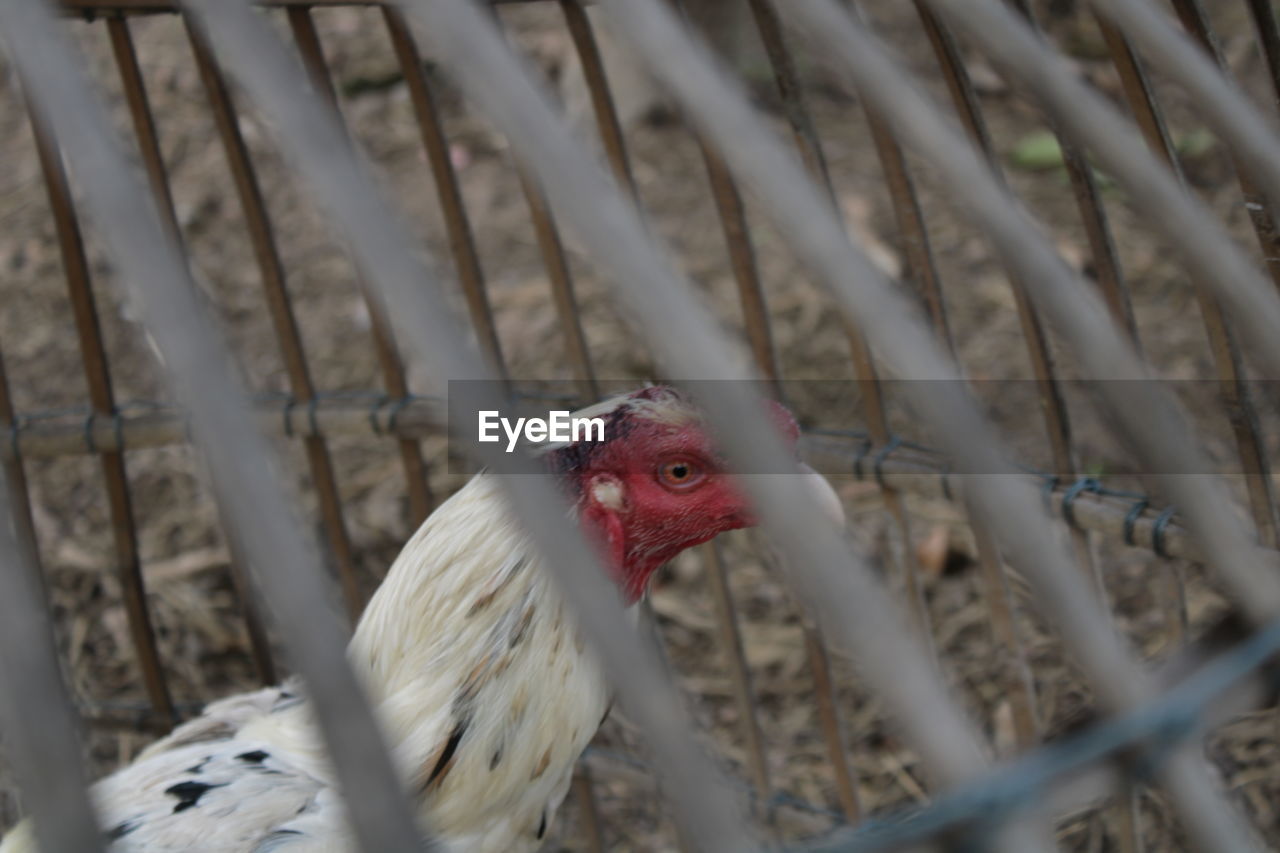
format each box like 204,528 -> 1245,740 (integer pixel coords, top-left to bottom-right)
0,0 -> 1280,850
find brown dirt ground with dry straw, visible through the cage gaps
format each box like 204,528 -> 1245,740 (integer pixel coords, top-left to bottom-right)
0,1 -> 1280,852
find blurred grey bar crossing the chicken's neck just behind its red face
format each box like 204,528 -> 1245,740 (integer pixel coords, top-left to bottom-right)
156,0 -> 750,850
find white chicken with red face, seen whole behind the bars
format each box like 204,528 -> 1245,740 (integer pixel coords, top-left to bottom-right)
0,387 -> 838,853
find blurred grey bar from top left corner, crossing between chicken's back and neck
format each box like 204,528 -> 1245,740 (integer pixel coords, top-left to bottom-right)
0,0 -> 435,852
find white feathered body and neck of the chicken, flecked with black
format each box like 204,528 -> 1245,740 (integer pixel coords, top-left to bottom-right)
0,474 -> 608,853
